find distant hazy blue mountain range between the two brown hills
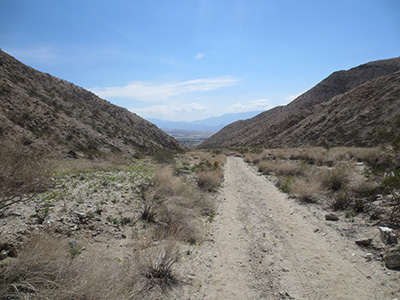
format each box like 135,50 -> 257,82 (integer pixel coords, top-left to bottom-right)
147,111 -> 261,131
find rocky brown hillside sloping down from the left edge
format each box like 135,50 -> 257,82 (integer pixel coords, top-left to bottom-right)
0,51 -> 183,157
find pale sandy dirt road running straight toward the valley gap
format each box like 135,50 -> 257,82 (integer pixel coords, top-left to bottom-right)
179,157 -> 400,300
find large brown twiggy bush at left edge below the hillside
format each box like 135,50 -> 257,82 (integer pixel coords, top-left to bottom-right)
0,140 -> 52,214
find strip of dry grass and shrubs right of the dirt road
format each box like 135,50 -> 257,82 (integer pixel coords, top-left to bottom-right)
242,136 -> 400,227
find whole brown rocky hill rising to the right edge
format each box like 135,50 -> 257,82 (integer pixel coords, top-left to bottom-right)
198,58 -> 400,148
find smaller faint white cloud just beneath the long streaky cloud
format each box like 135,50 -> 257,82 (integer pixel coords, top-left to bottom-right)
129,102 -> 209,120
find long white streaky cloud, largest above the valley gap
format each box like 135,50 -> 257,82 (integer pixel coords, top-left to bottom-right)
91,76 -> 239,102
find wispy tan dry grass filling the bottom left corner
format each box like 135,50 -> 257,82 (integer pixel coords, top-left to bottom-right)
0,234 -> 123,300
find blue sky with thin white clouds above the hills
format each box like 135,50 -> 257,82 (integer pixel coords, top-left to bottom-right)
0,0 -> 400,121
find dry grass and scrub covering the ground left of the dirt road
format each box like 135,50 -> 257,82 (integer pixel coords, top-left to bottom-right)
0,147 -> 225,300
